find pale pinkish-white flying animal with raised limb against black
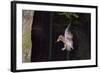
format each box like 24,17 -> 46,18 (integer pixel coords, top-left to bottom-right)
56,24 -> 74,51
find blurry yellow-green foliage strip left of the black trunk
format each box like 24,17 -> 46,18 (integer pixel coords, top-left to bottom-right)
22,31 -> 32,62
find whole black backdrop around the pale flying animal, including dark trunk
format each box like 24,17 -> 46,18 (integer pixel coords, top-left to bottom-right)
31,11 -> 91,62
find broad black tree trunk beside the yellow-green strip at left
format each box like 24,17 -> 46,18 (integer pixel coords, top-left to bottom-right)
31,11 -> 50,62
